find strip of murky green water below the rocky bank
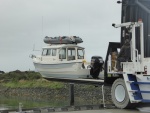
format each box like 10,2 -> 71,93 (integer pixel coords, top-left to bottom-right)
0,95 -> 68,109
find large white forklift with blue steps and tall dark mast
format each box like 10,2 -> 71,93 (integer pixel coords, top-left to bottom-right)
104,0 -> 150,108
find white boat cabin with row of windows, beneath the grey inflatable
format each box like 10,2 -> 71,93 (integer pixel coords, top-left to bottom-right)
41,44 -> 85,62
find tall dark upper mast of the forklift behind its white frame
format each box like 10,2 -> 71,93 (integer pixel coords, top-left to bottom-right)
118,0 -> 150,57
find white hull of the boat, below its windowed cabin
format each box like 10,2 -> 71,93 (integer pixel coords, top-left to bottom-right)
34,62 -> 90,78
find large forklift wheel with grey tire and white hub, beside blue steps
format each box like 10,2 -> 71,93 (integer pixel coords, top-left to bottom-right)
111,78 -> 136,109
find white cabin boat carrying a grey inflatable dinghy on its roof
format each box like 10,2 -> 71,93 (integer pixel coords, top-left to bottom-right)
31,36 -> 90,79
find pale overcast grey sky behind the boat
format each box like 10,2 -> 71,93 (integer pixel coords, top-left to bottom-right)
0,0 -> 121,72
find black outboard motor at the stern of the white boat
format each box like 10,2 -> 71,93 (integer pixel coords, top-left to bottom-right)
90,58 -> 102,79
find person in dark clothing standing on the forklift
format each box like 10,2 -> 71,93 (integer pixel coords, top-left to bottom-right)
116,36 -> 131,71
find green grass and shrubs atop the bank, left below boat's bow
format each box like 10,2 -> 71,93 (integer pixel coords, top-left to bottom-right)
0,70 -> 65,89
